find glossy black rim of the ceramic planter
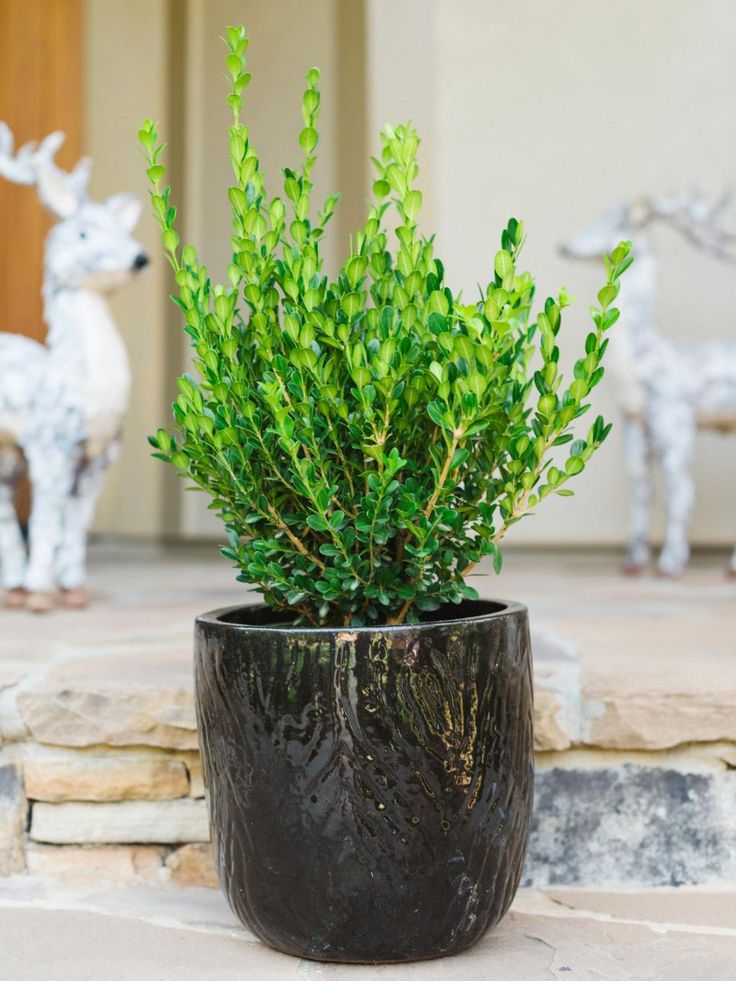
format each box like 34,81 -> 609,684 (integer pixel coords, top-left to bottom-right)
195,599 -> 528,637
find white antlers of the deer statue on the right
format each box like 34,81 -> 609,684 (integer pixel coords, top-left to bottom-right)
648,188 -> 736,262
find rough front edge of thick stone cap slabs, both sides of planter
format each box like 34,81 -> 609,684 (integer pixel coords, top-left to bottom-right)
7,631 -> 736,765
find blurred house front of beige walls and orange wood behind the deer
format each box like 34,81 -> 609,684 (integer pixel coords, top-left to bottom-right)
0,0 -> 736,546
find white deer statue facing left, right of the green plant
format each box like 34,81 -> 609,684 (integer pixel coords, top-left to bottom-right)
561,192 -> 736,576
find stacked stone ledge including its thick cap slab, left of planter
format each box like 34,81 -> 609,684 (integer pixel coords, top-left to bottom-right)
0,655 -> 216,886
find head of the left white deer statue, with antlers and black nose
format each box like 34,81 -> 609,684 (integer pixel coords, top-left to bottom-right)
0,122 -> 149,293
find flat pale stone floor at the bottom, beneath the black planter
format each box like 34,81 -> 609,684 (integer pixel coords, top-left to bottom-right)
0,876 -> 736,981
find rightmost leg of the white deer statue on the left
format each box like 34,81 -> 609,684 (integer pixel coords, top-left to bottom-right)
56,444 -> 117,609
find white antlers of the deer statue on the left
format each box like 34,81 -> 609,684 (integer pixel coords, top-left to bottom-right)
0,122 -> 92,218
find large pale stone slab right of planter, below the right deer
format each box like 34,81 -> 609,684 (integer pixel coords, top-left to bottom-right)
498,552 -> 736,750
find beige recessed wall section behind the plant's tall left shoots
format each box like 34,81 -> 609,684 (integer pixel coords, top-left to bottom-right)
176,0 -> 364,535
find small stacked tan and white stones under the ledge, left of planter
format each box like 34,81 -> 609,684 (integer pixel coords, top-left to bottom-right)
0,742 -> 217,886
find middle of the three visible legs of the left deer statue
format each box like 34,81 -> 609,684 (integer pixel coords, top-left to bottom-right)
25,446 -> 76,613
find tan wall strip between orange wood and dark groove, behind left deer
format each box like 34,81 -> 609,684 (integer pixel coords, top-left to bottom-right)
85,0 -> 175,536
